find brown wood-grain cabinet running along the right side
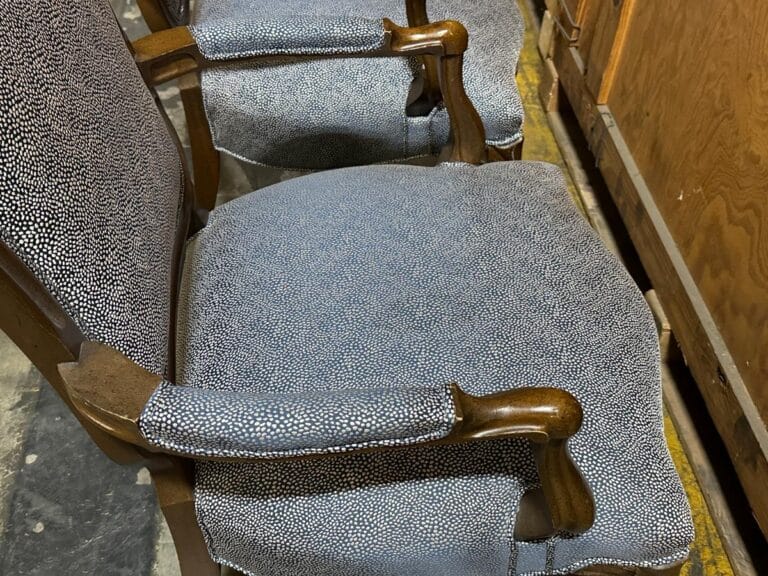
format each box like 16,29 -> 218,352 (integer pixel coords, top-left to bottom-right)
544,0 -> 768,536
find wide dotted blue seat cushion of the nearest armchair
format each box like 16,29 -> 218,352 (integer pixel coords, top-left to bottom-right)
178,162 -> 692,576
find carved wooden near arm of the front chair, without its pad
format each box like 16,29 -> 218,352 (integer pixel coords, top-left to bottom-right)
58,342 -> 594,536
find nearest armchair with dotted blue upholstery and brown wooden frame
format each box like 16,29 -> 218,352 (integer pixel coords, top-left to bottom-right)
0,0 -> 692,576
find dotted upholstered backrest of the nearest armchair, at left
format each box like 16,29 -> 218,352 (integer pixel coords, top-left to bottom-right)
0,0 -> 186,373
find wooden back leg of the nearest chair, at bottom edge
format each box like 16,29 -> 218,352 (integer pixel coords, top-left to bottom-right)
149,458 -> 221,576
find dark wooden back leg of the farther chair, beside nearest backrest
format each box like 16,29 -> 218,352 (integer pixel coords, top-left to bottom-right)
178,74 -> 220,210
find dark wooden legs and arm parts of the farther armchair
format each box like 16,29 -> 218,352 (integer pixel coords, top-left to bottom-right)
138,0 -> 523,210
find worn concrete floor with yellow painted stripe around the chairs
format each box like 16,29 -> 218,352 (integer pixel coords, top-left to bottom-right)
0,0 -> 732,576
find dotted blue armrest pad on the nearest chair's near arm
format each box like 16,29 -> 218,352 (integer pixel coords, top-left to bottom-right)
139,382 -> 456,458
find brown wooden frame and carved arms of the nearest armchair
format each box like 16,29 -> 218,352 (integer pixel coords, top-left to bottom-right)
0,15 -> 679,576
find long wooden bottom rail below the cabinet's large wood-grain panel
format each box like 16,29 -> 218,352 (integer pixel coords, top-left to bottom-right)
553,30 -> 768,537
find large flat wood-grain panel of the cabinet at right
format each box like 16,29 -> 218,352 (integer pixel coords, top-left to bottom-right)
608,0 -> 768,422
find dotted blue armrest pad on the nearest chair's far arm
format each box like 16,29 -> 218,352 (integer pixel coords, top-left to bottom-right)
192,16 -> 386,60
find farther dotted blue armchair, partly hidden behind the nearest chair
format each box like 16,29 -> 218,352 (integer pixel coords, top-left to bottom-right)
132,0 -> 523,207
